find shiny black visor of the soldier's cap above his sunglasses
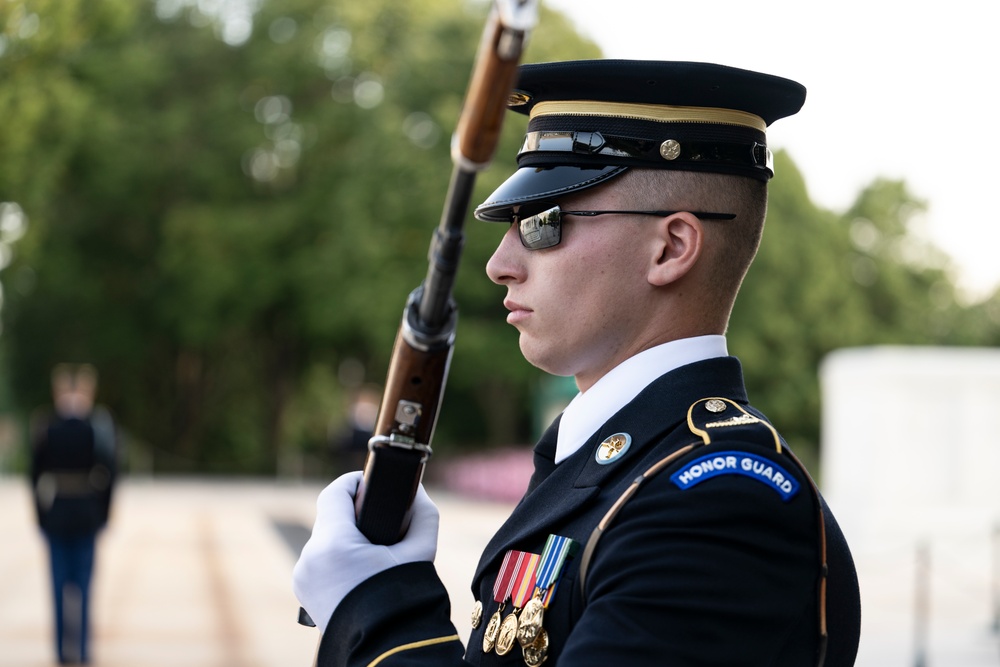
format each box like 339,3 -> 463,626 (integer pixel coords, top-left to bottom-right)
475,166 -> 628,222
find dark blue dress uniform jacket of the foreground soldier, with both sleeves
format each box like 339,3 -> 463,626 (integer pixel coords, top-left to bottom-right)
318,357 -> 861,667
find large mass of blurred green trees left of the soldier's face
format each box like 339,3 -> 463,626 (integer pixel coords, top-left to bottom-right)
0,0 -> 598,472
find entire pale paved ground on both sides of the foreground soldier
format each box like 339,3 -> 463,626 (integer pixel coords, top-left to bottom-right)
0,477 -> 1000,667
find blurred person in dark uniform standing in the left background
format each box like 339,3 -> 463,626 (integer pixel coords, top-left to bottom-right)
31,364 -> 117,664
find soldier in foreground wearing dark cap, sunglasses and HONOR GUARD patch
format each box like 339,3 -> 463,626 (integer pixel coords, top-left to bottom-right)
294,61 -> 860,667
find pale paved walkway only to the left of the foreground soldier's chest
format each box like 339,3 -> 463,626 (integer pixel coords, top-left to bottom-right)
0,477 -> 509,667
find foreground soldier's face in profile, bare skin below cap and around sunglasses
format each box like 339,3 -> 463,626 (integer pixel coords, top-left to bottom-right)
486,187 -> 656,390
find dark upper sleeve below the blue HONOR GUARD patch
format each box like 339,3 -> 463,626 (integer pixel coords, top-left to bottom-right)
560,444 -> 820,667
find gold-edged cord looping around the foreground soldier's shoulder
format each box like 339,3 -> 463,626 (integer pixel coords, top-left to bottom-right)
580,398 -> 829,667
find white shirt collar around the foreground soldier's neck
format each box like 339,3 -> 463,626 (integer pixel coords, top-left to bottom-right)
555,335 -> 729,463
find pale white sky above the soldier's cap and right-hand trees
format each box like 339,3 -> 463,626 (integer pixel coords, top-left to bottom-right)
533,0 -> 1000,302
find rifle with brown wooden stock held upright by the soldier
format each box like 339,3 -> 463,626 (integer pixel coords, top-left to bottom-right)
356,0 -> 538,544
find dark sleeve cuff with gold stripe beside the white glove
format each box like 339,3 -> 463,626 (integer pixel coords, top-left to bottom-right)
316,562 -> 468,667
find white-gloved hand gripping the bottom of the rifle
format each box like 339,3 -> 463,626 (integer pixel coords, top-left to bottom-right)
292,471 -> 439,632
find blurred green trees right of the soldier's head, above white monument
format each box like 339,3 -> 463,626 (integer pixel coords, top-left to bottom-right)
729,153 -> 972,456
